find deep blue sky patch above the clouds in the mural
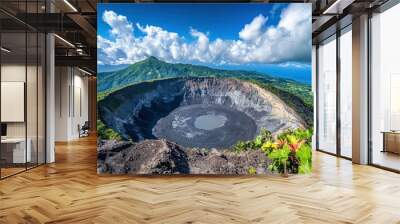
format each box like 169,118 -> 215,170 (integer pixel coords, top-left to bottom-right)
97,3 -> 287,40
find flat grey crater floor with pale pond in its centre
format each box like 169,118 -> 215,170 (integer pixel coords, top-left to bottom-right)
153,104 -> 257,148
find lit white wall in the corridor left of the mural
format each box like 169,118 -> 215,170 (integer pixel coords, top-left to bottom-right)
55,67 -> 89,141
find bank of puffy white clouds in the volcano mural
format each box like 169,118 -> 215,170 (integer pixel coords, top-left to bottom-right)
98,4 -> 311,65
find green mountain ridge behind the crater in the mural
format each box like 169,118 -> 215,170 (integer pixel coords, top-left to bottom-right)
97,56 -> 313,124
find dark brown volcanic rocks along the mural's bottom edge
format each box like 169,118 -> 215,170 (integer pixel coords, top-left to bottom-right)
97,139 -> 268,175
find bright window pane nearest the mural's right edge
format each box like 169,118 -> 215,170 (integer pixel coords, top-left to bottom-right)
318,37 -> 336,153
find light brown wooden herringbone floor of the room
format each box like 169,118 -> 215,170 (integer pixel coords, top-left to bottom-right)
0,138 -> 400,224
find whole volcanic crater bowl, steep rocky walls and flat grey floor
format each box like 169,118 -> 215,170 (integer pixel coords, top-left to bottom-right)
98,77 -> 305,148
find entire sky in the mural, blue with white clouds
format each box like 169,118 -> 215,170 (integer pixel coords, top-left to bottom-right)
97,4 -> 311,82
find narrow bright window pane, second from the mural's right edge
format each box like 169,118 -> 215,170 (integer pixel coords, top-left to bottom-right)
340,29 -> 353,158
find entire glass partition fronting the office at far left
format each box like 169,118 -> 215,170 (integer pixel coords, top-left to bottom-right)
0,0 -> 46,178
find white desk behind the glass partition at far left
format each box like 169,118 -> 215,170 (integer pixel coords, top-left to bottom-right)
1,138 -> 32,163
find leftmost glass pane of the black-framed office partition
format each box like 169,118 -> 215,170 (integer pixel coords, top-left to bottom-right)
1,32 -> 27,177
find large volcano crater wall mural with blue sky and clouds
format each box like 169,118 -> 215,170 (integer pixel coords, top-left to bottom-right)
97,3 -> 313,175
